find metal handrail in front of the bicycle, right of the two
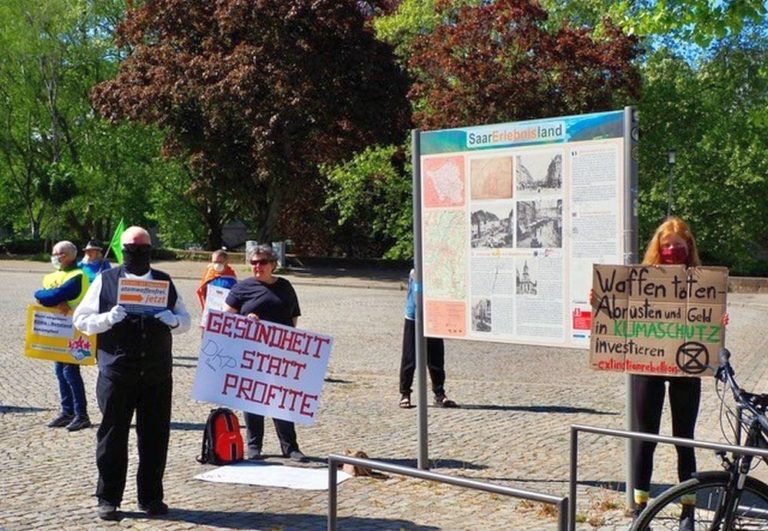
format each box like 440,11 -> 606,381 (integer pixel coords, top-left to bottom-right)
568,424 -> 768,531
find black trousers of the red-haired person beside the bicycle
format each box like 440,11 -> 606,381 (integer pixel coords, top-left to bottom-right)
630,374 -> 701,491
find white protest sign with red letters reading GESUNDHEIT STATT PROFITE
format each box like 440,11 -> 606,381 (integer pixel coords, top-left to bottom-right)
192,310 -> 333,425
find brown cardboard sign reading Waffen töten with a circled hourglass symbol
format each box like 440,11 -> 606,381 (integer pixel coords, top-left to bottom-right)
590,264 -> 728,376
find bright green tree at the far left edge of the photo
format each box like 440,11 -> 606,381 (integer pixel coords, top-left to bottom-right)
0,0 -> 85,238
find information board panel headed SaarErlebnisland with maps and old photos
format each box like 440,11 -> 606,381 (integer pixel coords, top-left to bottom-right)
419,111 -> 630,348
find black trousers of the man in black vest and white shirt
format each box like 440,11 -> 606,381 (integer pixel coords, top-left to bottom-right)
96,374 -> 173,505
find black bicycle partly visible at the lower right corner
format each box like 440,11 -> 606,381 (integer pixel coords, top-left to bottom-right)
631,348 -> 768,531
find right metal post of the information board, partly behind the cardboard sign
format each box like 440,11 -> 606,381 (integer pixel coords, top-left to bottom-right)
623,107 -> 640,507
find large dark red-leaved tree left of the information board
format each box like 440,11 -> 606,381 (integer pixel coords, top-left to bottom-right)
91,0 -> 410,248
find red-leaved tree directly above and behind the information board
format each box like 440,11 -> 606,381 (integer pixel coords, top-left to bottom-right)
409,0 -> 640,129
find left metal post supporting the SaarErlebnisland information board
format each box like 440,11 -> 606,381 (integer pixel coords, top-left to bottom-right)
411,129 -> 429,470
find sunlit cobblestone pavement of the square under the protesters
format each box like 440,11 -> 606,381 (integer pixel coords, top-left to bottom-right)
0,261 -> 768,530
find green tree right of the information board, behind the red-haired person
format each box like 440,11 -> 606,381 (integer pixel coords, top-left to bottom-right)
639,39 -> 768,274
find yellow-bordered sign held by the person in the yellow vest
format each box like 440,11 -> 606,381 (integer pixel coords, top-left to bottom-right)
24,304 -> 96,365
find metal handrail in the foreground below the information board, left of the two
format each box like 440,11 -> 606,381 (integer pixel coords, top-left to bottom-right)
328,454 -> 569,531
